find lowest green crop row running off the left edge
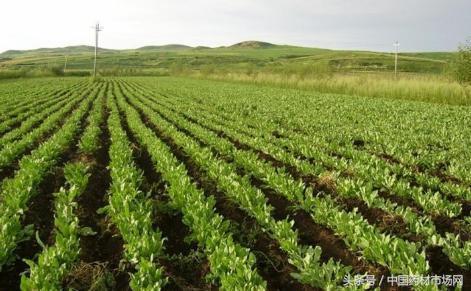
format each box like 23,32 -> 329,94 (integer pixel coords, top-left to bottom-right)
0,86 -> 95,270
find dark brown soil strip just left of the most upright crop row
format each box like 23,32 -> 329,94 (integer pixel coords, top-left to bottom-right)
64,102 -> 129,290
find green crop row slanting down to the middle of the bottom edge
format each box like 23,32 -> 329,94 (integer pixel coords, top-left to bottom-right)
118,83 -> 266,290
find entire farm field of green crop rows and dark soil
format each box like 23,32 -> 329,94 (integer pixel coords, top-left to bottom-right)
0,77 -> 471,290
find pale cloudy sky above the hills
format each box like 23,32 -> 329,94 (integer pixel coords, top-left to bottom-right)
0,0 -> 471,52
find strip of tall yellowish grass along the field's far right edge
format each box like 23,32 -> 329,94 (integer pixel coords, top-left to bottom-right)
193,72 -> 471,105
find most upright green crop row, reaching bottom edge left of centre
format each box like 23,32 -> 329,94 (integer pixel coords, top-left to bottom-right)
105,90 -> 168,290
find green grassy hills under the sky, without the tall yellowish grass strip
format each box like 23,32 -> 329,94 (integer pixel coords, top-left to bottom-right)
0,41 -> 458,74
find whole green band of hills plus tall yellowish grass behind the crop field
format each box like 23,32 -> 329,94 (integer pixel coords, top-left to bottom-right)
0,41 -> 471,105
